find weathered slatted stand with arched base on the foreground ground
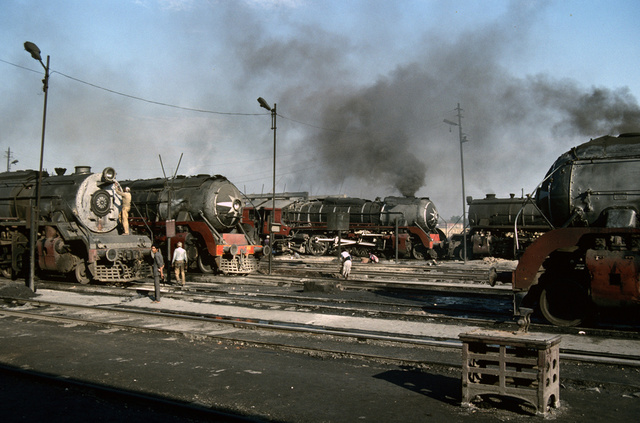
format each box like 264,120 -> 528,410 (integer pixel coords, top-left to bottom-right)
459,329 -> 560,415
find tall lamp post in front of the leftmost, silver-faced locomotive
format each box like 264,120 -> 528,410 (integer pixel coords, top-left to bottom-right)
24,41 -> 49,291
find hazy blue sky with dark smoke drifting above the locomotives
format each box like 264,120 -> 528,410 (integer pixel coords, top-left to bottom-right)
0,0 -> 640,218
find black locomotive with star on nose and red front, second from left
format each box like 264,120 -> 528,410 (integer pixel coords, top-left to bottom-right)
121,175 -> 263,274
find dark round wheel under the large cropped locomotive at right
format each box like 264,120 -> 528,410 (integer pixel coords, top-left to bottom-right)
540,279 -> 592,326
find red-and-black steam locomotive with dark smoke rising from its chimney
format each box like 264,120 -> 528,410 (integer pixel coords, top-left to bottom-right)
243,193 -> 445,259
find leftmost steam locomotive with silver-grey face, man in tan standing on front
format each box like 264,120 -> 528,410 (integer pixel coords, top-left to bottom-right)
0,166 -> 151,283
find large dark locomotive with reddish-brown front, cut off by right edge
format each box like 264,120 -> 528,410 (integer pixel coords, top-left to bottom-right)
492,133 -> 640,326
